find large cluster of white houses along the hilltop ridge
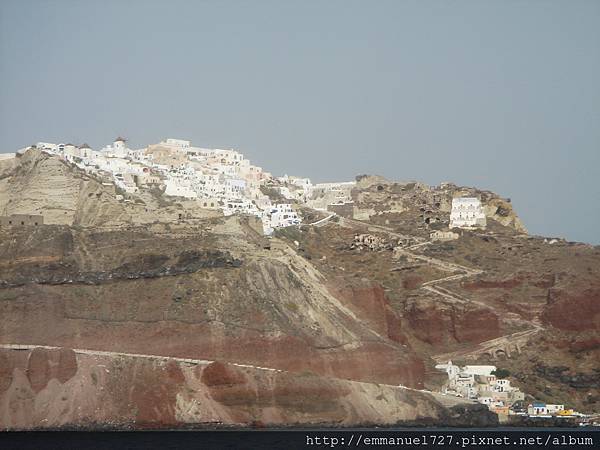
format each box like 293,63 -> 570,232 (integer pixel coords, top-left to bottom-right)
30,137 -> 354,234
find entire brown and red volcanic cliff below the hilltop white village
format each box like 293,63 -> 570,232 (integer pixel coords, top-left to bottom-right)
0,152 -> 600,428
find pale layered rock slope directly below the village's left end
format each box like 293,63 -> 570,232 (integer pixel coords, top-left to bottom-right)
0,149 -> 222,227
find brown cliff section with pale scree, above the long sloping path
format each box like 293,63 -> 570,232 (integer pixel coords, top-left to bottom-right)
0,222 -> 423,386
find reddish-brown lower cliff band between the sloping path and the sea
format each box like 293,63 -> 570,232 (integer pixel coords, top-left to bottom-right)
0,348 -> 497,429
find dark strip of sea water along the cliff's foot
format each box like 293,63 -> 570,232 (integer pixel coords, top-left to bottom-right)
0,427 -> 600,450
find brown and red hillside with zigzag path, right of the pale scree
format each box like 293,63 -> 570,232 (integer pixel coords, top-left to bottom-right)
279,177 -> 600,411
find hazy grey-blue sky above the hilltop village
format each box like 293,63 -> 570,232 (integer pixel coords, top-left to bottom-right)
0,0 -> 600,243
